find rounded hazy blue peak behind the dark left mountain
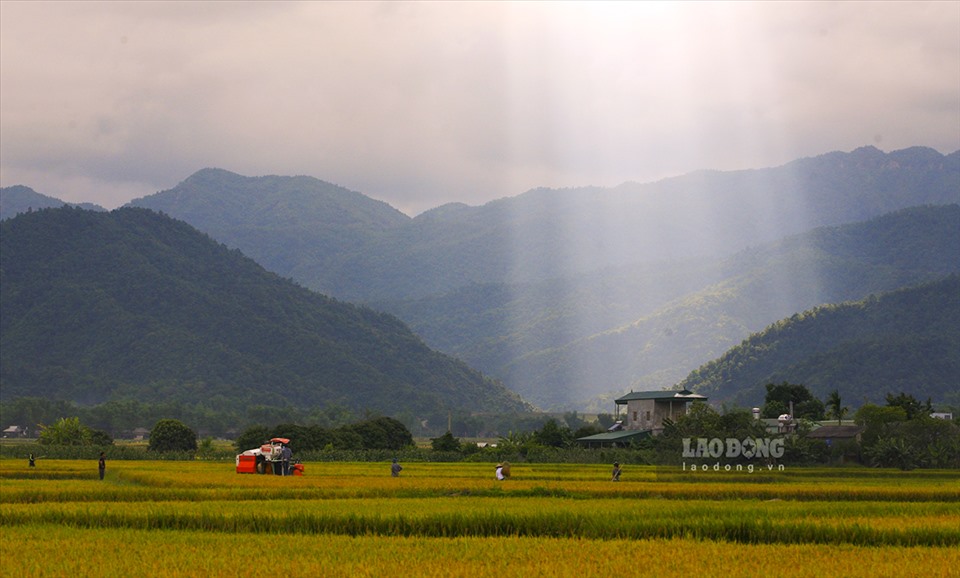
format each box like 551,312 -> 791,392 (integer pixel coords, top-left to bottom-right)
128,169 -> 410,295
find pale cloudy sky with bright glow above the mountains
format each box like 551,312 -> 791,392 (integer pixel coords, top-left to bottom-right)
0,0 -> 960,216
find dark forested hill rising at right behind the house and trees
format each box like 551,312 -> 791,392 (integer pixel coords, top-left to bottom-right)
680,275 -> 960,405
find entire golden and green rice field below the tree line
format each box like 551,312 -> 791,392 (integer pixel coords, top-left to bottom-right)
0,459 -> 960,577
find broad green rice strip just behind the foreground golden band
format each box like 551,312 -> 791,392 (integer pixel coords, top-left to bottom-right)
0,497 -> 960,546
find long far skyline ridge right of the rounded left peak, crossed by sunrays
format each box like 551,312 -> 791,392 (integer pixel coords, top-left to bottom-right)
340,147 -> 960,301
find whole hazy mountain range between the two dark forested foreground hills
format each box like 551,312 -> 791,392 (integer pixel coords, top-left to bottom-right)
0,147 -> 960,411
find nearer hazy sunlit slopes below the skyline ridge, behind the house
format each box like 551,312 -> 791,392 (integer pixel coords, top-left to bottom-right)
381,205 -> 960,411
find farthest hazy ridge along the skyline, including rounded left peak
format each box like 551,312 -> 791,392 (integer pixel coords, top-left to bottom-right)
131,147 -> 960,302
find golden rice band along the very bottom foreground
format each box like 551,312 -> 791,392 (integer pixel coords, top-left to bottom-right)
0,525 -> 960,578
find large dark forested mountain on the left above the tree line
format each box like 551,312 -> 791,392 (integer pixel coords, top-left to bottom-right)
0,208 -> 526,416
